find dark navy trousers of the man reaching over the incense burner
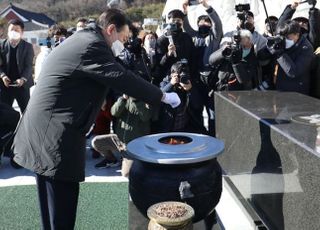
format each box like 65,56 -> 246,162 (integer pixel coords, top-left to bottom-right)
36,174 -> 79,230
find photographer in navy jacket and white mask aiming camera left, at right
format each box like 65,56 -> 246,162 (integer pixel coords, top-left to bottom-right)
258,21 -> 314,94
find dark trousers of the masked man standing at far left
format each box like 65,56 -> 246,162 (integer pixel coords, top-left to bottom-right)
0,86 -> 30,113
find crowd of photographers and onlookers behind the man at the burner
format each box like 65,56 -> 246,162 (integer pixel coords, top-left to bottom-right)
0,0 -> 320,172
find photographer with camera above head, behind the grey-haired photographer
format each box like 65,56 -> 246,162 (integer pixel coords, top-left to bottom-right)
221,4 -> 267,53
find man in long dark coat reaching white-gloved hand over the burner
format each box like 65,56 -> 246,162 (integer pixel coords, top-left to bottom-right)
13,9 -> 180,229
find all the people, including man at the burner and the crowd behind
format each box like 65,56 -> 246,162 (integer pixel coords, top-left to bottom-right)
0,0 -> 320,229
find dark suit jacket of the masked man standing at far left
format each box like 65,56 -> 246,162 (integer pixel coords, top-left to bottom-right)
0,39 -> 34,88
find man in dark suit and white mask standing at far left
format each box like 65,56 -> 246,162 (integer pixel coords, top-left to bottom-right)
0,19 -> 34,113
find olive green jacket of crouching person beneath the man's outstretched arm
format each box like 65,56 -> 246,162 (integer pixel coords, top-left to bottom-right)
111,97 -> 152,144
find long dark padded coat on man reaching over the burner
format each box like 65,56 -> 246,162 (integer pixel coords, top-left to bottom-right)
13,28 -> 163,182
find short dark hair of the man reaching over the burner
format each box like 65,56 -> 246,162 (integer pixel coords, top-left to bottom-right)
97,8 -> 128,32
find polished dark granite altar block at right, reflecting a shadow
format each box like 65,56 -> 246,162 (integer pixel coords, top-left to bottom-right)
215,91 -> 320,230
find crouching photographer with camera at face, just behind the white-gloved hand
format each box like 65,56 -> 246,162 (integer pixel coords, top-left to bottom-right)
157,60 -> 192,133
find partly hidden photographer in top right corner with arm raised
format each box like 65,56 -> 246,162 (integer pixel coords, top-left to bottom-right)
278,0 -> 320,49
